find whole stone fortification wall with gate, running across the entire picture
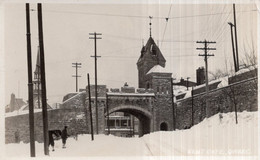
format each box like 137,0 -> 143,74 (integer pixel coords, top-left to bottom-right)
5,77 -> 258,143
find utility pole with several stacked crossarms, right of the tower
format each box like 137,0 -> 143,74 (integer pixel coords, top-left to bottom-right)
197,40 -> 216,117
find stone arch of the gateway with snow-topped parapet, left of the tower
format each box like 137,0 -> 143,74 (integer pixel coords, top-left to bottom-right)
105,92 -> 154,136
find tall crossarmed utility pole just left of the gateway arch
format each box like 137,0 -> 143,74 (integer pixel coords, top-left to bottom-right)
89,32 -> 102,134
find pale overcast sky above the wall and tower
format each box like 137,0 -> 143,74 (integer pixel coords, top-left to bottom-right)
2,0 -> 259,105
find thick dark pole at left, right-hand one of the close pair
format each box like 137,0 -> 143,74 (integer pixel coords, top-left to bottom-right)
37,3 -> 49,155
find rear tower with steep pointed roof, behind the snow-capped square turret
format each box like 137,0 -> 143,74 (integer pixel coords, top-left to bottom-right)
137,37 -> 166,88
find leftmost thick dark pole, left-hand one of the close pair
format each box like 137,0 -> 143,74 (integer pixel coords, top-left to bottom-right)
25,3 -> 35,157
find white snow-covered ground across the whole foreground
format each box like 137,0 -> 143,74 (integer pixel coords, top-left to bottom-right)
6,112 -> 258,159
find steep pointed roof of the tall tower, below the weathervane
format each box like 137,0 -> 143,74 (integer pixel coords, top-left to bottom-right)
137,37 -> 166,67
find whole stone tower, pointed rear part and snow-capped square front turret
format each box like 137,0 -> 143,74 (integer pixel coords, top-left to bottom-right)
137,37 -> 173,131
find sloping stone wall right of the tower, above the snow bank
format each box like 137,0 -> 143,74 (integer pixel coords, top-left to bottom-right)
175,78 -> 258,129
